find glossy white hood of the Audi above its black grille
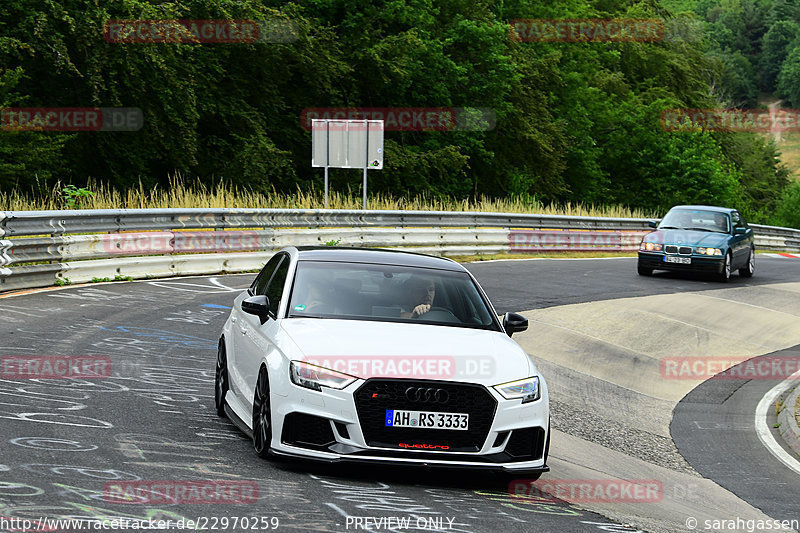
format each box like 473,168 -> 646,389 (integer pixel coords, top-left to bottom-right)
281,318 -> 538,386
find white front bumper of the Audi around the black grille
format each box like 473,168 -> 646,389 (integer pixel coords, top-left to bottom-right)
271,380 -> 550,473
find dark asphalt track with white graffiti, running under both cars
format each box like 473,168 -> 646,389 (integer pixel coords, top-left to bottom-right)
0,258 -> 800,532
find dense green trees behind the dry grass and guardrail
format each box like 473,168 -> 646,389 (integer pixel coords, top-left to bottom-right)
0,0 -> 800,218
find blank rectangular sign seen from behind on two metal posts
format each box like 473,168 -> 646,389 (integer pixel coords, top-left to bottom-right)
311,119 -> 383,211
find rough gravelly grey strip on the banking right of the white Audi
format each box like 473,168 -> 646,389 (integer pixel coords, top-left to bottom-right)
550,398 -> 700,477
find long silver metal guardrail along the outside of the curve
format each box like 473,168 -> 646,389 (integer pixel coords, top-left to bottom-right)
0,209 -> 800,291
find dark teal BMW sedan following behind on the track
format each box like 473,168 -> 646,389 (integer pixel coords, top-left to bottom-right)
638,205 -> 756,281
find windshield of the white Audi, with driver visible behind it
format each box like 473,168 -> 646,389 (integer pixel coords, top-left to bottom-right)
287,261 -> 500,331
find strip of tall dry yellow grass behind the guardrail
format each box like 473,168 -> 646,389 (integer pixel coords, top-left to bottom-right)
0,178 -> 653,218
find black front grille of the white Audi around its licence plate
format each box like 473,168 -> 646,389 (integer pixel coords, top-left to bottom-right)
355,379 -> 497,452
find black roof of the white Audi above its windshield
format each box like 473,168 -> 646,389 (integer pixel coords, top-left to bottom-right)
296,246 -> 466,272
